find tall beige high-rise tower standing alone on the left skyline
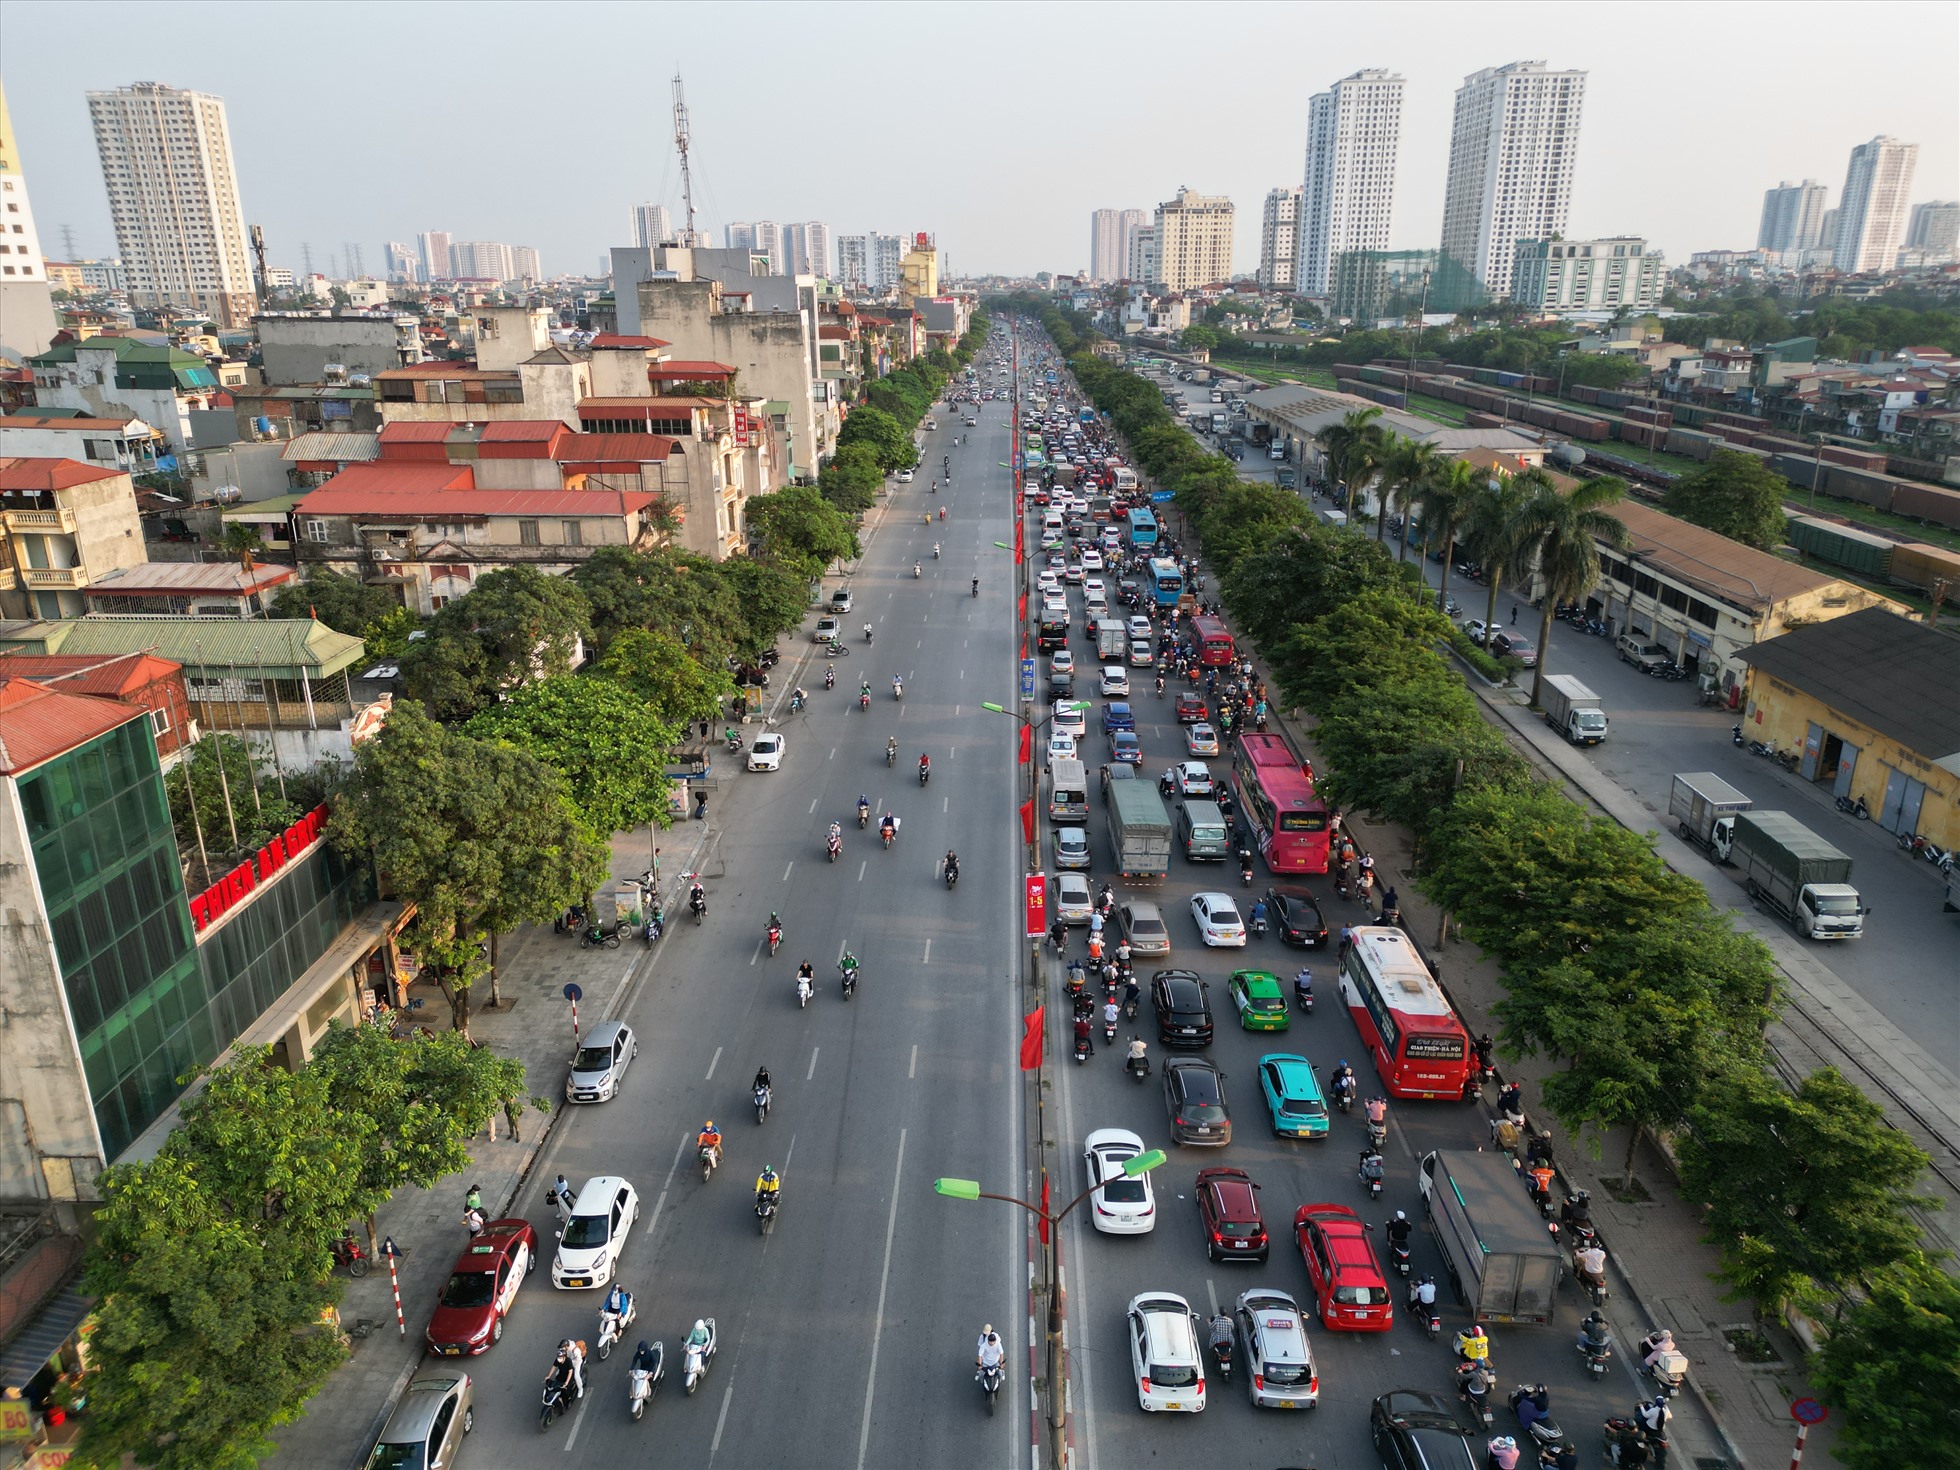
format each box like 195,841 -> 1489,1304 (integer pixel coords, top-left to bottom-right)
88,82 -> 255,327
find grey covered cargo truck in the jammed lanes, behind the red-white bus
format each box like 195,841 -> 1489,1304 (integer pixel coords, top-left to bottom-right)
1415,1149 -> 1566,1323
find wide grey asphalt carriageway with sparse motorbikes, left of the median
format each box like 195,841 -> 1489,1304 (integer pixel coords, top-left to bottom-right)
448,376 -> 1029,1466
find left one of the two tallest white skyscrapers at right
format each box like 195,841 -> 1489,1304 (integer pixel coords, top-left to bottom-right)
1296,71 -> 1401,296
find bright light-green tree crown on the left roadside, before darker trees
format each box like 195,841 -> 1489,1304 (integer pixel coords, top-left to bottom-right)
463,674 -> 680,837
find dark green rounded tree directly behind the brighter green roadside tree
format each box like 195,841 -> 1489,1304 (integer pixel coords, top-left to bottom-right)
402,566 -> 592,721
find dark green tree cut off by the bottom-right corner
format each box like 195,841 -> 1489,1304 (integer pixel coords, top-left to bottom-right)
1813,1256 -> 1960,1470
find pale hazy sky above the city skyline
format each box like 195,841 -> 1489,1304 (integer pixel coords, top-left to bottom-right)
0,0 -> 1960,274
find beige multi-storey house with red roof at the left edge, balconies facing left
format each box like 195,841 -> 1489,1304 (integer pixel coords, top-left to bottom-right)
0,457 -> 143,617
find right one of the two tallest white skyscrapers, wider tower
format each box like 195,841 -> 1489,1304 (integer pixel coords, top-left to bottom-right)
1443,61 -> 1586,296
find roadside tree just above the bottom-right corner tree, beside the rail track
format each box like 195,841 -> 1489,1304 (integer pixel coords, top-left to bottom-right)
1680,1066 -> 1935,1307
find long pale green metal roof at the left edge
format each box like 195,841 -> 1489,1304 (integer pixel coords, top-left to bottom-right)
0,617 -> 365,678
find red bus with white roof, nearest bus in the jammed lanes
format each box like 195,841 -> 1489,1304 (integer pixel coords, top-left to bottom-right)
1341,923 -> 1470,1102
